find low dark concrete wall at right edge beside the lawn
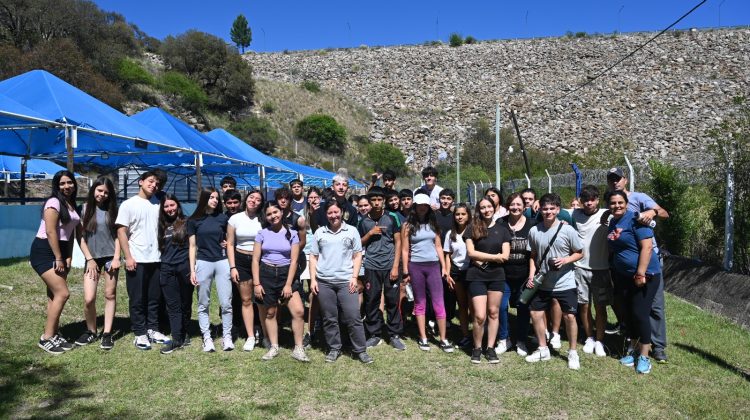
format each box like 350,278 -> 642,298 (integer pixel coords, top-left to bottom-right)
664,257 -> 750,329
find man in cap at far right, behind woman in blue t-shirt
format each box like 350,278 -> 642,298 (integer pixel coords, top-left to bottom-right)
605,168 -> 669,363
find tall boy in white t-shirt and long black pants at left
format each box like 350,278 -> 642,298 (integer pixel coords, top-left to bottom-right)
115,171 -> 168,350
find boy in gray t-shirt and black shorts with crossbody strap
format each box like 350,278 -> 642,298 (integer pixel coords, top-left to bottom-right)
526,194 -> 583,370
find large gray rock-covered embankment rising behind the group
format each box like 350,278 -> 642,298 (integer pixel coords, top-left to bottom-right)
245,29 -> 750,168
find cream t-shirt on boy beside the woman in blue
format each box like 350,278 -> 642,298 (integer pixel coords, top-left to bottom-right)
573,209 -> 609,270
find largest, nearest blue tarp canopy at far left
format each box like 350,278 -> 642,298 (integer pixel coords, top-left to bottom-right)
0,70 -> 193,167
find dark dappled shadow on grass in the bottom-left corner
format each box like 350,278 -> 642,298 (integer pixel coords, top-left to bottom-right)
0,350 -> 132,418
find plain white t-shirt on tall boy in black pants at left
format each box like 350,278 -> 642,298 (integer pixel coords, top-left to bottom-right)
115,195 -> 161,263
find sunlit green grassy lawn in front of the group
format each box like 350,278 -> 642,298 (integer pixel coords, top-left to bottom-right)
0,260 -> 750,418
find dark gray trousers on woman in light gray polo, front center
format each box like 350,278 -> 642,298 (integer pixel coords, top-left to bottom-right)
318,281 -> 367,353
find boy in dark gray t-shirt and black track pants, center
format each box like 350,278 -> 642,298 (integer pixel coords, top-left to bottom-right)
358,187 -> 406,350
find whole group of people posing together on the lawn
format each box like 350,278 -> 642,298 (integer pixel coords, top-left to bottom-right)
31,167 -> 669,373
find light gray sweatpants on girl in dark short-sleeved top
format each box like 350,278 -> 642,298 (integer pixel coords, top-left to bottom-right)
195,259 -> 232,337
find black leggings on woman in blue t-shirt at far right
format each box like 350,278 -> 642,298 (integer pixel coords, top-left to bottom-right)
615,273 -> 662,344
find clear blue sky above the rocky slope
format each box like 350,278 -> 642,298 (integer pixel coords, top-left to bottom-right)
95,0 -> 750,51
